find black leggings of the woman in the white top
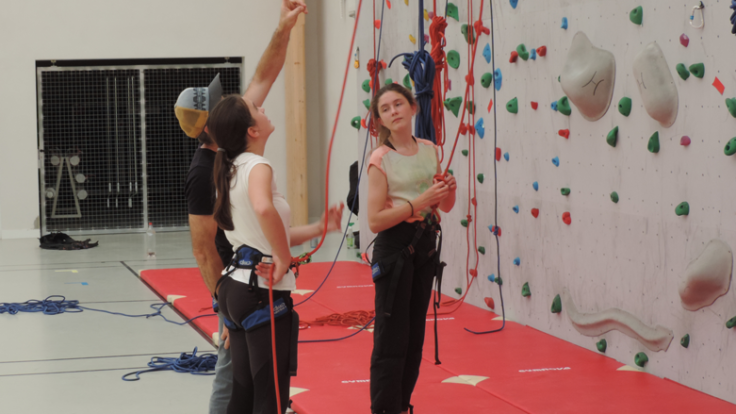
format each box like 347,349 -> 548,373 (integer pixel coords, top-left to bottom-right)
218,276 -> 293,414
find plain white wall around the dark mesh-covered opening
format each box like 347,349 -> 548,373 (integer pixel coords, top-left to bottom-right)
0,0 -> 288,238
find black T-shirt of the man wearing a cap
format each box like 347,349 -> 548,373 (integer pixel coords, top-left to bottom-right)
184,147 -> 233,266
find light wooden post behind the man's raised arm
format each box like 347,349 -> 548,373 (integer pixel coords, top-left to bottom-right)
284,14 -> 309,226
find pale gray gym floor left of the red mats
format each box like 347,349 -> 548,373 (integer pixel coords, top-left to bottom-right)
0,232 -> 356,414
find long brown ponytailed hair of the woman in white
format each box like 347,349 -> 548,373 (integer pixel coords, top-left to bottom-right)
207,95 -> 255,231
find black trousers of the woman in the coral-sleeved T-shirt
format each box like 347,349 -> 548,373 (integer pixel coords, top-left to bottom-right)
370,222 -> 437,414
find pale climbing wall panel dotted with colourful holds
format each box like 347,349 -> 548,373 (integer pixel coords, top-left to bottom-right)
356,0 -> 736,402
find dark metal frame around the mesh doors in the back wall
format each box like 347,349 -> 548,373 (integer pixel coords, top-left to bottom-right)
36,61 -> 245,235
